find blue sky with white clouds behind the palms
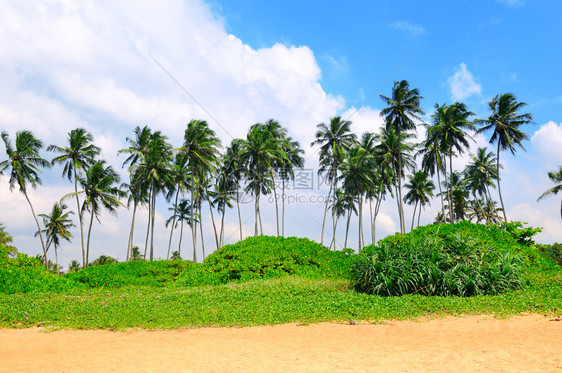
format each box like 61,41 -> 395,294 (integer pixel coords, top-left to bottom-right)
0,0 -> 562,264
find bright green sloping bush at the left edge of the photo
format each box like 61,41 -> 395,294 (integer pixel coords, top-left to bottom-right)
0,246 -> 80,294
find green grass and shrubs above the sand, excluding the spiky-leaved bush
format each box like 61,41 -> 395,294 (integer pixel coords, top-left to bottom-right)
0,228 -> 562,329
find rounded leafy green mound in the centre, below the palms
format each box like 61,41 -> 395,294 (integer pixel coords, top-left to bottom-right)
178,236 -> 352,286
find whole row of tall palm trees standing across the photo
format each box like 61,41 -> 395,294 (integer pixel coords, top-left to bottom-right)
0,80 -> 532,267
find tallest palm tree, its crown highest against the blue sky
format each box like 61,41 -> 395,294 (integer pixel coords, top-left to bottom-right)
380,80 -> 424,233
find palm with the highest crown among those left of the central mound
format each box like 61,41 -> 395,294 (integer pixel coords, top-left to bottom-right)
180,119 -> 221,263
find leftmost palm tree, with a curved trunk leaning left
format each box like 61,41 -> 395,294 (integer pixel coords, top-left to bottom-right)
0,130 -> 51,269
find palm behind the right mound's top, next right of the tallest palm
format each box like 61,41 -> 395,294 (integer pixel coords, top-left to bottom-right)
428,102 -> 475,221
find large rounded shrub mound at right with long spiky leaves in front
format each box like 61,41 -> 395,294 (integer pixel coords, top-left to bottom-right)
352,222 -> 540,296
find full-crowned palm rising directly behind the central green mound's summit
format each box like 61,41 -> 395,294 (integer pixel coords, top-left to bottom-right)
240,123 -> 282,236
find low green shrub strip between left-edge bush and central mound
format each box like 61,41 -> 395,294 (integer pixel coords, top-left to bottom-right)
65,260 -> 190,288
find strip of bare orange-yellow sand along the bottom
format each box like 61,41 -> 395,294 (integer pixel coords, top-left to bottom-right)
0,315 -> 562,372
